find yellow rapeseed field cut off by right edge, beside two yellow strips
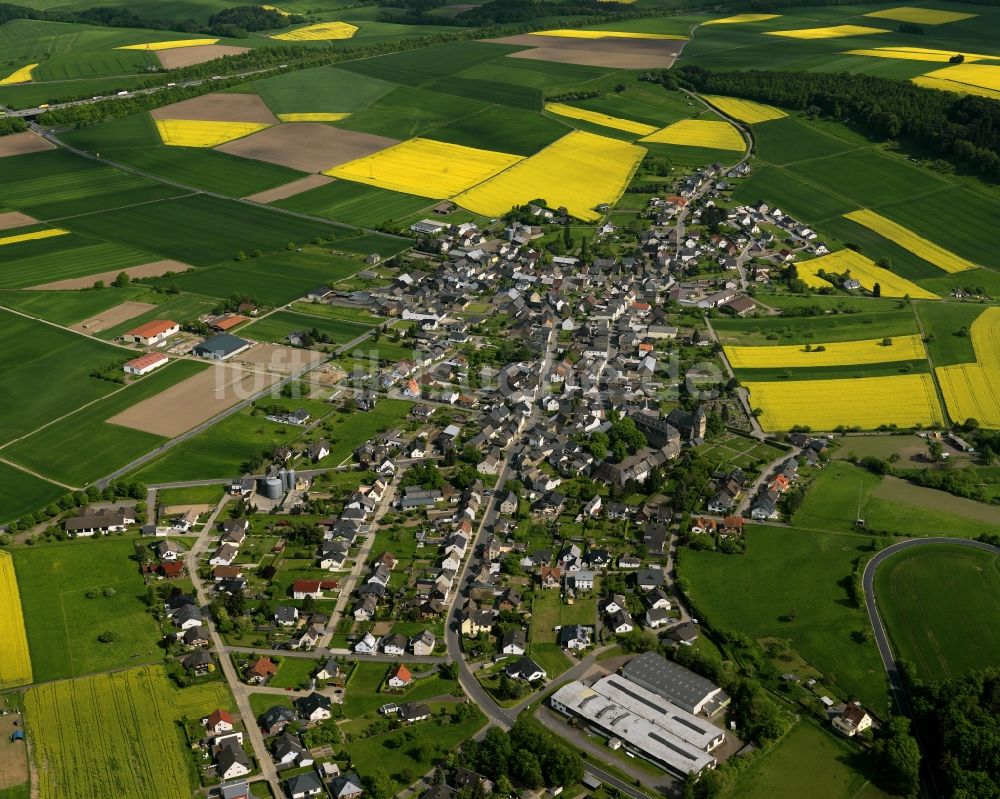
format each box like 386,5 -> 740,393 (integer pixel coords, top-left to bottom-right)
935,308 -> 1000,428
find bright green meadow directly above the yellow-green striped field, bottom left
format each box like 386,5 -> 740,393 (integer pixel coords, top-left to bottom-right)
12,536 -> 162,682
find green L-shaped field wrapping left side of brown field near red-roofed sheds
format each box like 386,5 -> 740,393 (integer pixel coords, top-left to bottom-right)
0,361 -> 209,486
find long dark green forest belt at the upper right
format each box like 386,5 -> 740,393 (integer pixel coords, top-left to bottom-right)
676,65 -> 1000,181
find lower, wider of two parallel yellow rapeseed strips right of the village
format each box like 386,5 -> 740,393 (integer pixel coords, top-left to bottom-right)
743,374 -> 942,431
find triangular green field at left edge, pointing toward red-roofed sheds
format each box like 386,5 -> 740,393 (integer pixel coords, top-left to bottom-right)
0,310 -> 127,444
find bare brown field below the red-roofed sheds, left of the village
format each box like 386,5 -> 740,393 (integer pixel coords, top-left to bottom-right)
107,364 -> 280,438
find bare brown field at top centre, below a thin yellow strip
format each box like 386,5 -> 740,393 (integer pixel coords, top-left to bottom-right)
486,33 -> 685,69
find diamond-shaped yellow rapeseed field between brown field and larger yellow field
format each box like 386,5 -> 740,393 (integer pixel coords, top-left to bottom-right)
324,139 -> 524,200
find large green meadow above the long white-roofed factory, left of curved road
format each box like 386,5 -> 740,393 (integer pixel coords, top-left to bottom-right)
678,524 -> 887,713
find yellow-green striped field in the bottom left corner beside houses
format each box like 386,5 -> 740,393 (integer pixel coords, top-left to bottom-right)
25,667 -> 231,799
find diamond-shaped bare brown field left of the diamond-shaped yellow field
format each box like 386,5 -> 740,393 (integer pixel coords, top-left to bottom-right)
215,122 -> 399,172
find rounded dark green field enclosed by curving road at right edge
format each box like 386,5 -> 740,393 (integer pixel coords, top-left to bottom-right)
875,545 -> 1000,681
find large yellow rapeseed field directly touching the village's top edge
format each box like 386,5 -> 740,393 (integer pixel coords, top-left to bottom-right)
454,130 -> 646,222
